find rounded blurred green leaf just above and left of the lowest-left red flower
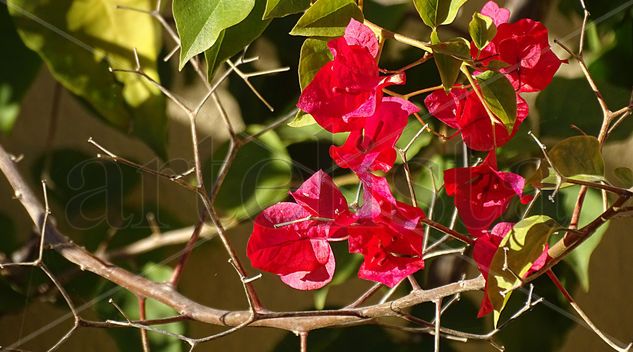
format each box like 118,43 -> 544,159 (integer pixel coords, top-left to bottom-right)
205,126 -> 292,219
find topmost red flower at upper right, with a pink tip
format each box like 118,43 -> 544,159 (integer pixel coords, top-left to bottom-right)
471,2 -> 562,92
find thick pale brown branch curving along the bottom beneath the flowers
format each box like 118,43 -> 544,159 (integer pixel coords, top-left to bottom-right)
0,145 -> 485,332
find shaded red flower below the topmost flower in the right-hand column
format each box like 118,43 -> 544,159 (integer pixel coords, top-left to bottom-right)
424,88 -> 529,151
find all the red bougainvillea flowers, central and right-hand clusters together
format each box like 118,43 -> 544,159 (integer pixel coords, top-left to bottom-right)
247,1 -> 561,315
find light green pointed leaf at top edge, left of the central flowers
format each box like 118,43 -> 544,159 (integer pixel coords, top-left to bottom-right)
172,0 -> 255,70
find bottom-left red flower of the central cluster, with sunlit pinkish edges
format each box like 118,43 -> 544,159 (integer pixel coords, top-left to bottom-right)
246,170 -> 352,290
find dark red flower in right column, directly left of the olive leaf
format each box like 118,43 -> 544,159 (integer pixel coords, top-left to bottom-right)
444,152 -> 531,236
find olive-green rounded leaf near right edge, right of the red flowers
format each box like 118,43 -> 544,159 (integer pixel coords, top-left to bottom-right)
549,136 -> 604,180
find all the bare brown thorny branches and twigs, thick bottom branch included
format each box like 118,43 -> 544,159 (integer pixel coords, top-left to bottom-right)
0,1 -> 633,351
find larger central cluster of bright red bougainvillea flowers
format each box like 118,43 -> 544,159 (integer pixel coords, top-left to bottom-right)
247,20 -> 424,290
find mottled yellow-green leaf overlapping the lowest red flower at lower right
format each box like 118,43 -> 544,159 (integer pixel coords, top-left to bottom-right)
486,215 -> 559,327
